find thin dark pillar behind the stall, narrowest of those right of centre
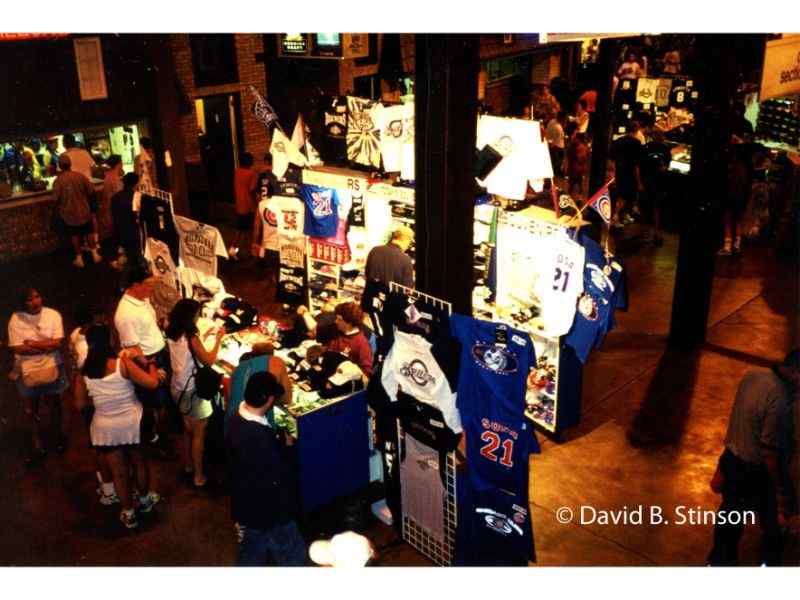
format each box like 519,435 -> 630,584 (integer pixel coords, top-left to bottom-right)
589,39 -> 617,196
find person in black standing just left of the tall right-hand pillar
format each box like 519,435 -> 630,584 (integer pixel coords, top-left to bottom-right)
639,127 -> 672,246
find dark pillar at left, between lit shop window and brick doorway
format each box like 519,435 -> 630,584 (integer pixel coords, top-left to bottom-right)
148,35 -> 189,215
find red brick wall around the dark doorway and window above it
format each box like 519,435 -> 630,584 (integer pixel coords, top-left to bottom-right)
171,33 -> 268,162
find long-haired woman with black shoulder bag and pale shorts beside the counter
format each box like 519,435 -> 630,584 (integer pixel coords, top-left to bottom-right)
166,298 -> 225,488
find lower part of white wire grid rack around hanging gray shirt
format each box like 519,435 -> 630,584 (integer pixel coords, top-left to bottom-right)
397,421 -> 458,567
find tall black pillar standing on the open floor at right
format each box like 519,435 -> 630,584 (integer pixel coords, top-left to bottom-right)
669,34 -> 753,350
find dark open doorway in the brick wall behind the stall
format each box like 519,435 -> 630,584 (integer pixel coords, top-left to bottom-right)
196,92 -> 244,203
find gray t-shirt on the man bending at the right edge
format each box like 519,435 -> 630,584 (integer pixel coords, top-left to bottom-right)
725,369 -> 792,464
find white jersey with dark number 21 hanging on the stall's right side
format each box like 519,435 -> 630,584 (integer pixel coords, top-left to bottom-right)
536,232 -> 585,337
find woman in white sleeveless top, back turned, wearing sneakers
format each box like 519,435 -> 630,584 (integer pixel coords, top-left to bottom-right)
75,324 -> 166,529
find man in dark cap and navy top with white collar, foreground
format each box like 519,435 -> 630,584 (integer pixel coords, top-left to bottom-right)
225,371 -> 307,566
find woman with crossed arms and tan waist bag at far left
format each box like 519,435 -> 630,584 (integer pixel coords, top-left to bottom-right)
8,286 -> 68,465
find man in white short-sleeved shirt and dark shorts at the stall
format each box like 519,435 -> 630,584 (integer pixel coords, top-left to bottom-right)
114,264 -> 171,454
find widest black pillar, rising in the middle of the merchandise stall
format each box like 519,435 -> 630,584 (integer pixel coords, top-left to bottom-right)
414,34 -> 478,314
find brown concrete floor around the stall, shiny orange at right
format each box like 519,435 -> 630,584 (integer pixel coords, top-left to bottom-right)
0,212 -> 800,566
